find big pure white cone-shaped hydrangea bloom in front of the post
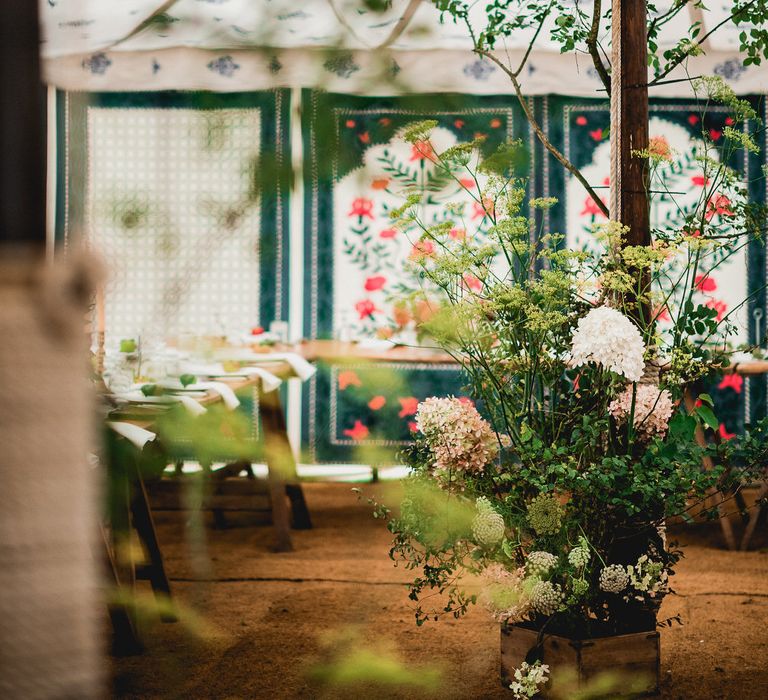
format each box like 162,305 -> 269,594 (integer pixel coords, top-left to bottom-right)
571,306 -> 645,382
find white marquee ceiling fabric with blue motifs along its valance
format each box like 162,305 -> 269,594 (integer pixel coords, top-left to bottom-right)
41,0 -> 768,97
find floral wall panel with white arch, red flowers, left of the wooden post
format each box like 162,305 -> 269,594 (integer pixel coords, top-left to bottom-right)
305,93 -> 527,338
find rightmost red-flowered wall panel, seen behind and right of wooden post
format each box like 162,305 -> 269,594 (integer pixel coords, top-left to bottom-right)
547,93 -> 765,438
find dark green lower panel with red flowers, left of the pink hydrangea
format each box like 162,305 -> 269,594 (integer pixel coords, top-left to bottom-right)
303,362 -> 464,464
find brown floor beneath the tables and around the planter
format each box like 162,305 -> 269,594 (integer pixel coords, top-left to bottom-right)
112,483 -> 768,700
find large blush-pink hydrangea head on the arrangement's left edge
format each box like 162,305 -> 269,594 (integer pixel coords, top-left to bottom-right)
416,396 -> 499,483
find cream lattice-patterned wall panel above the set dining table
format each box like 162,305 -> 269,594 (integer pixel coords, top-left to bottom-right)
57,90 -> 286,347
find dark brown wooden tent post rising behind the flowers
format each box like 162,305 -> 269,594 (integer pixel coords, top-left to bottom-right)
610,0 -> 651,326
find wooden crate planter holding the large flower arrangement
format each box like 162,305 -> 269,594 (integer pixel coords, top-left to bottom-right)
501,625 -> 660,697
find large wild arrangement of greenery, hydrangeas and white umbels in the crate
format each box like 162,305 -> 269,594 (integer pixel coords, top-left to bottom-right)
383,105 -> 765,644
